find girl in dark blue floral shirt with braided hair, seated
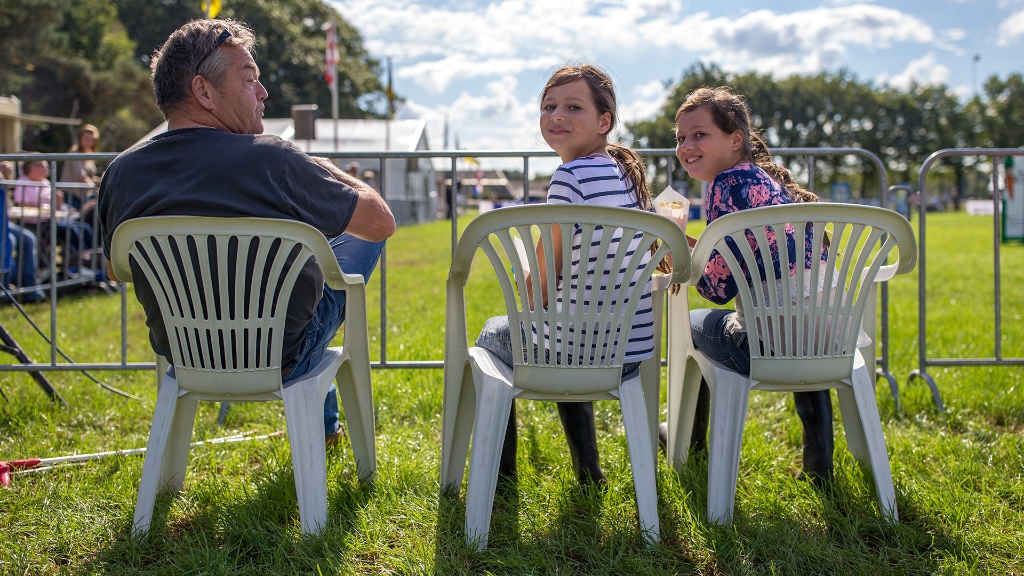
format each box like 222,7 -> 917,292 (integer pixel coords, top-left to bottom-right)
659,87 -> 834,485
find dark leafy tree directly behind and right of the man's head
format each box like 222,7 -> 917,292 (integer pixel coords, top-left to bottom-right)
114,0 -> 385,118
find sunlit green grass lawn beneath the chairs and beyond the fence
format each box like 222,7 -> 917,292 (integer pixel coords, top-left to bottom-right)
0,214 -> 1024,575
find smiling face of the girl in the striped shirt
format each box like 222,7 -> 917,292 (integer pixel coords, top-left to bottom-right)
541,80 -> 611,162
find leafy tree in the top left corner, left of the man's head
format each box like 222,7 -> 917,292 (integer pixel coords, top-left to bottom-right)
0,0 -> 159,152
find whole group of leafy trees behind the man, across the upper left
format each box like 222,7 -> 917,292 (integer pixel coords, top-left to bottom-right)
0,0 -> 386,152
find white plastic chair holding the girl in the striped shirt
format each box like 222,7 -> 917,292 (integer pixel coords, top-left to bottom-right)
441,205 -> 689,548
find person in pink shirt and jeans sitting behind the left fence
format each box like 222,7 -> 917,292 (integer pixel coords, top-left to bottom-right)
14,160 -> 92,272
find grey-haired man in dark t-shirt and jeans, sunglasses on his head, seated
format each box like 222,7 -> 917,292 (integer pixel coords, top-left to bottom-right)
98,19 -> 395,443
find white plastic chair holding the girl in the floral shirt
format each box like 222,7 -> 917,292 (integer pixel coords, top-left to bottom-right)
667,203 -> 918,524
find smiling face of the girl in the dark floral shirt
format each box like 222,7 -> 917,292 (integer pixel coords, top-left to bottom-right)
676,107 -> 744,183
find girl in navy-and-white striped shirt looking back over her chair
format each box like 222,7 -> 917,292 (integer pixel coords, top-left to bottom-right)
476,65 -> 654,484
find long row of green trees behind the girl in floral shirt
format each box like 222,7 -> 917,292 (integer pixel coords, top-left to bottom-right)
628,63 -> 1024,198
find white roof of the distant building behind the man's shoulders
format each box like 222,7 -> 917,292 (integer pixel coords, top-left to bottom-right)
139,118 -> 429,152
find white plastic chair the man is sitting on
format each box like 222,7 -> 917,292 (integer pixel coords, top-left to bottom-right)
112,216 -> 377,534
